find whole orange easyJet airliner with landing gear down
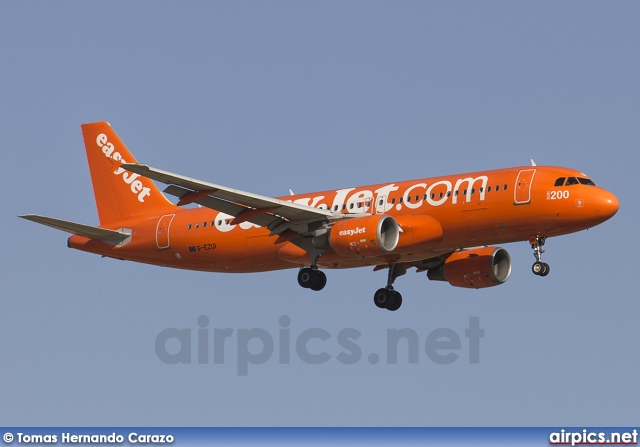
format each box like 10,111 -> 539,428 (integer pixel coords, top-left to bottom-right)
20,122 -> 618,311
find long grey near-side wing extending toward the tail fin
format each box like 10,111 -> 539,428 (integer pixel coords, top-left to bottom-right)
122,163 -> 338,234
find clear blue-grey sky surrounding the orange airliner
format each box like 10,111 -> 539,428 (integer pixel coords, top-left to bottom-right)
0,1 -> 640,426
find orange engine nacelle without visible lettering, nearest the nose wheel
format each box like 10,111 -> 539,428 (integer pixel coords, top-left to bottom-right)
427,247 -> 511,289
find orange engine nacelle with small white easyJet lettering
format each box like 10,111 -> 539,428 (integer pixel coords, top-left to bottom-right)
329,214 -> 400,258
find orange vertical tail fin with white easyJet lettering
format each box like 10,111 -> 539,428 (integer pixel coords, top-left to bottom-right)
81,122 -> 176,225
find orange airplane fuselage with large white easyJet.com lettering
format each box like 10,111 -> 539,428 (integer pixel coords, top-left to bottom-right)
69,166 -> 618,273
